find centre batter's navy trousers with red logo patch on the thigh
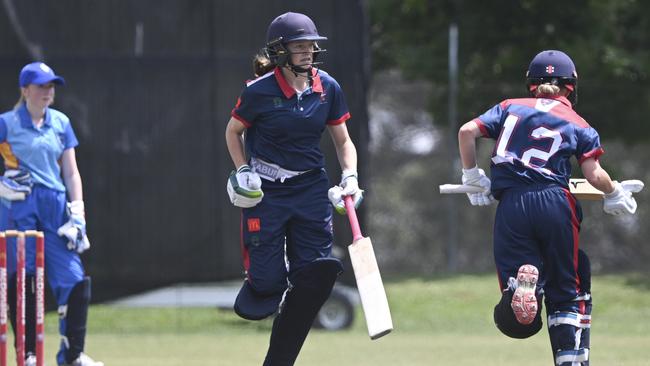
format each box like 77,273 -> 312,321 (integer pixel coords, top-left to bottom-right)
242,169 -> 333,293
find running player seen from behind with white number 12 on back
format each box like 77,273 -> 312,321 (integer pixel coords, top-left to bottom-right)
458,50 -> 637,366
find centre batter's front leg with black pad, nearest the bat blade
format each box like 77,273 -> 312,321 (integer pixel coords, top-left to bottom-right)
264,172 -> 343,366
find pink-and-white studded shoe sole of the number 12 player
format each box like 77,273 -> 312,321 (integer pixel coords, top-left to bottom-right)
510,264 -> 539,325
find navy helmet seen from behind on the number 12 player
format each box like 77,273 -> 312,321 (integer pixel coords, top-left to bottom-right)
526,50 -> 578,105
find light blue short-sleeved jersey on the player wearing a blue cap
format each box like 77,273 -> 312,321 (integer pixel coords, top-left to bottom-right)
0,103 -> 79,192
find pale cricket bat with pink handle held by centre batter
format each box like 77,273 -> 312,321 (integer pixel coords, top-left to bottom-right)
344,196 -> 393,340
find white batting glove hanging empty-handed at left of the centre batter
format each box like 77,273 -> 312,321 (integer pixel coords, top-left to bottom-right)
226,164 -> 264,208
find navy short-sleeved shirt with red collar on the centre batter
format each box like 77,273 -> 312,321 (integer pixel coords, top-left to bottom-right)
231,67 -> 350,171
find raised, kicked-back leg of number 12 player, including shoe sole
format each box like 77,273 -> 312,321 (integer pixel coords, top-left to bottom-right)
494,191 -> 544,338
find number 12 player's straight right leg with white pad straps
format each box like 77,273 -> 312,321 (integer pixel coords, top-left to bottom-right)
538,190 -> 591,366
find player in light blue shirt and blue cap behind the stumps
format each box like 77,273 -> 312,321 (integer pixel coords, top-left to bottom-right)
0,62 -> 103,366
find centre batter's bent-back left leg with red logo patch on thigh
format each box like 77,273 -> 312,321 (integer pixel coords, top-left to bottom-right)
234,192 -> 289,320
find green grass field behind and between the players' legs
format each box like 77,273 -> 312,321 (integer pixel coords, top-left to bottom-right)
24,274 -> 650,366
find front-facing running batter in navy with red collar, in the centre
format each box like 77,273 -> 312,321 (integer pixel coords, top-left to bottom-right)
225,12 -> 362,366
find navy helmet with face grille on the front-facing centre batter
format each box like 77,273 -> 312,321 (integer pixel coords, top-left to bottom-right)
264,12 -> 327,72
